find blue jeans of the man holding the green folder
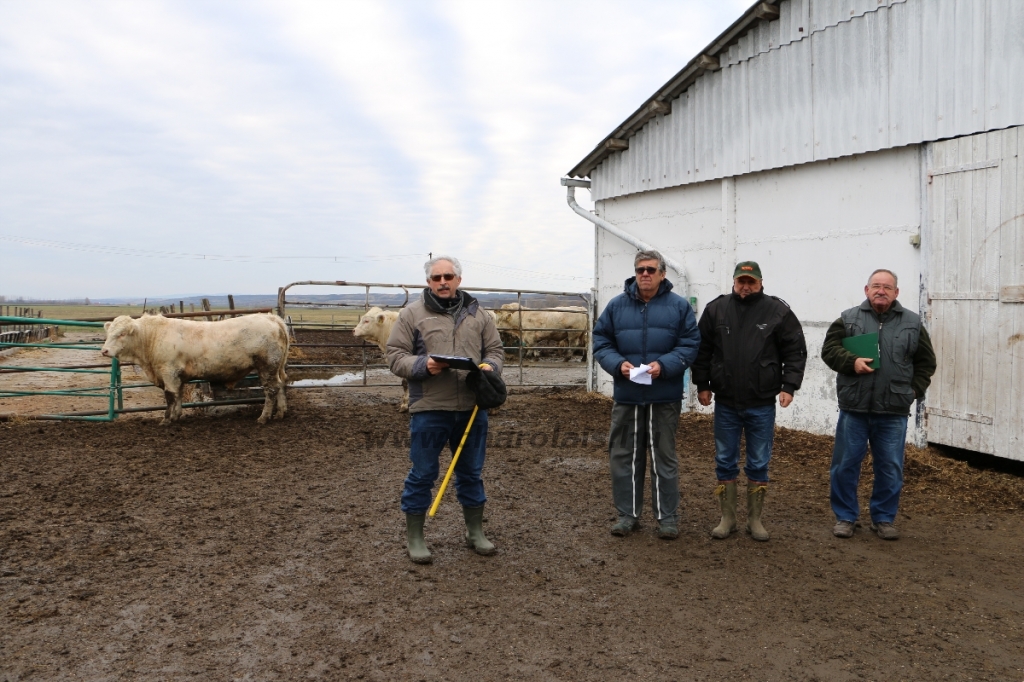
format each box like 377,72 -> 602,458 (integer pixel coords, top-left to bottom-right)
828,410 -> 907,523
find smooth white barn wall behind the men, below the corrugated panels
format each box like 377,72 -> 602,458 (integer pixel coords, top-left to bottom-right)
597,145 -> 922,440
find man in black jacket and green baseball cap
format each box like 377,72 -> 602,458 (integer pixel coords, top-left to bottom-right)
693,260 -> 807,541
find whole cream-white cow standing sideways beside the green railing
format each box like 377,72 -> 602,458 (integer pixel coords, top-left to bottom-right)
101,314 -> 289,424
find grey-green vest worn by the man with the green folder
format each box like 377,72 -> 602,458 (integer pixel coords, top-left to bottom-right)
836,300 -> 921,415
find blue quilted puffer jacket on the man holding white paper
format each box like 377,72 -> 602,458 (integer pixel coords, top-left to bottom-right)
594,278 -> 700,404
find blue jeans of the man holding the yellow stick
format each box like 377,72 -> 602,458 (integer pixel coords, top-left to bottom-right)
401,410 -> 487,514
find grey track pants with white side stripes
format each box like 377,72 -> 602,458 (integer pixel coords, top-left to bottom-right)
608,401 -> 682,521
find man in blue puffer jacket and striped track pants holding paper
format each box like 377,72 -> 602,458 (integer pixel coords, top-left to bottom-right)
594,251 -> 700,540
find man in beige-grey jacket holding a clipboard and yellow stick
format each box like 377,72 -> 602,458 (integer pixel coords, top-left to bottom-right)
387,256 -> 504,563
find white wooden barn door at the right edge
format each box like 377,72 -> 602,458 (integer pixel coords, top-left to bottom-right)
922,127 -> 1024,460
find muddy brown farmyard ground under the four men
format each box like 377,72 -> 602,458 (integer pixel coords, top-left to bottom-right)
0,382 -> 1024,682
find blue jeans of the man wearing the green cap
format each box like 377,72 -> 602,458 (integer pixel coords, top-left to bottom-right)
715,402 -> 775,483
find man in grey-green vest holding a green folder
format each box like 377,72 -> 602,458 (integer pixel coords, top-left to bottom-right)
821,269 -> 936,540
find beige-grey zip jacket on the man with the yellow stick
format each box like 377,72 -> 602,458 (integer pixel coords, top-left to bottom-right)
387,292 -> 505,413
